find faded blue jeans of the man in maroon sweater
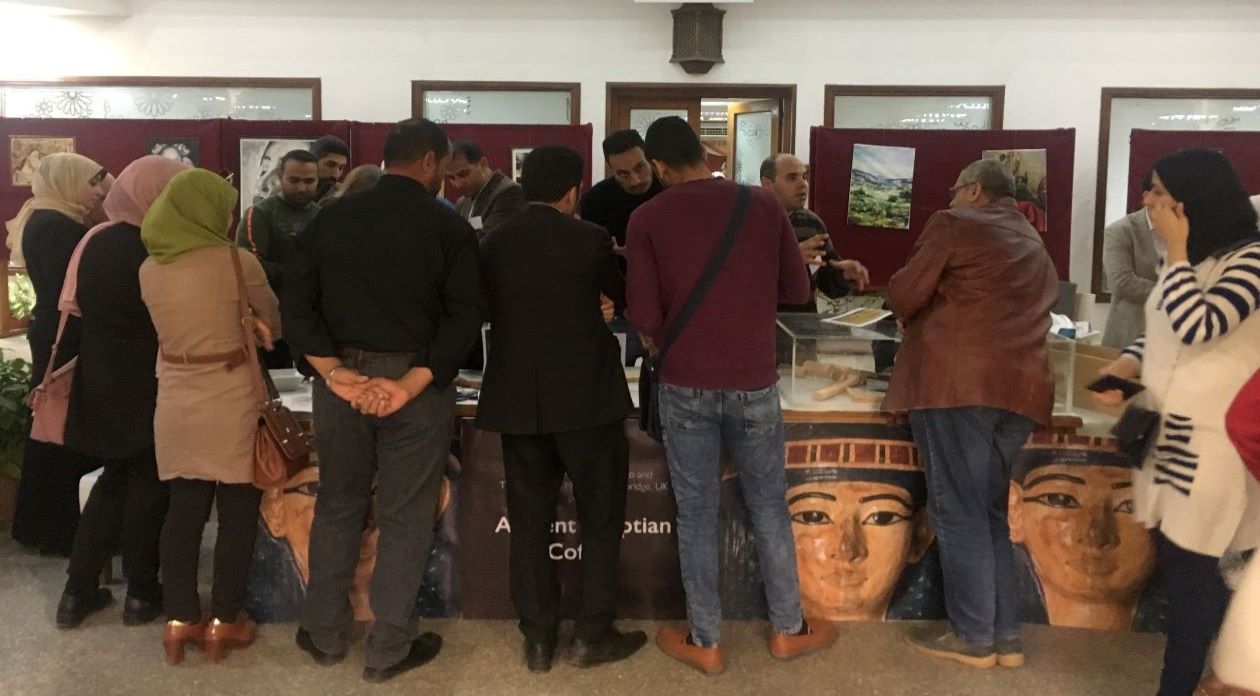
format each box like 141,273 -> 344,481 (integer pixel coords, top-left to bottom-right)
660,383 -> 801,647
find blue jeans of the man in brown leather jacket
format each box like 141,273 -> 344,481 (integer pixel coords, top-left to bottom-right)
910,406 -> 1036,648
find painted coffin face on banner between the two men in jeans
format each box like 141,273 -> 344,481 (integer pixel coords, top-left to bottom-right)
788,439 -> 932,620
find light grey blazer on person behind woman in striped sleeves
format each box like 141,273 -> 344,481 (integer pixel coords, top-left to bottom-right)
1103,209 -> 1159,348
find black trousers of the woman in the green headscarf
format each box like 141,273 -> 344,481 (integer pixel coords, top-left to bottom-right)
161,478 -> 262,622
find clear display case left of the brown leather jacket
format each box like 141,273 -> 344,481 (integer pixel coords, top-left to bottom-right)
776,313 -> 901,411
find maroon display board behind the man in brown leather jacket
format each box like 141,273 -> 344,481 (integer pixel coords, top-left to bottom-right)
809,127 -> 1076,287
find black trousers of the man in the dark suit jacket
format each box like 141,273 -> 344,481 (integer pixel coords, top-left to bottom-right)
501,421 -> 630,643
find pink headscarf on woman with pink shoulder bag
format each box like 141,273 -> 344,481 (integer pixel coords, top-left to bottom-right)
57,155 -> 190,316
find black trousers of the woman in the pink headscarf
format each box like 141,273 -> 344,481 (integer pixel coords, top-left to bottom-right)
66,450 -> 169,601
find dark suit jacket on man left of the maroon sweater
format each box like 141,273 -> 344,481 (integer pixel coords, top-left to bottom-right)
476,204 -> 631,435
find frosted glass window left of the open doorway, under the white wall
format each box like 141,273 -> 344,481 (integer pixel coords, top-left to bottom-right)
425,90 -> 573,126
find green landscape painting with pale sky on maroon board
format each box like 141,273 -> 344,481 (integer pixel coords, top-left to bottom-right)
848,144 -> 915,229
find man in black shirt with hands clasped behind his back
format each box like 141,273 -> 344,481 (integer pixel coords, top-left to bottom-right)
282,119 -> 481,682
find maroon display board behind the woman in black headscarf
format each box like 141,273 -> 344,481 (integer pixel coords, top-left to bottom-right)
1128,130 -> 1260,211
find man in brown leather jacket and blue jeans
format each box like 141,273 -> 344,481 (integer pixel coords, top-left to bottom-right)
885,160 -> 1058,667
